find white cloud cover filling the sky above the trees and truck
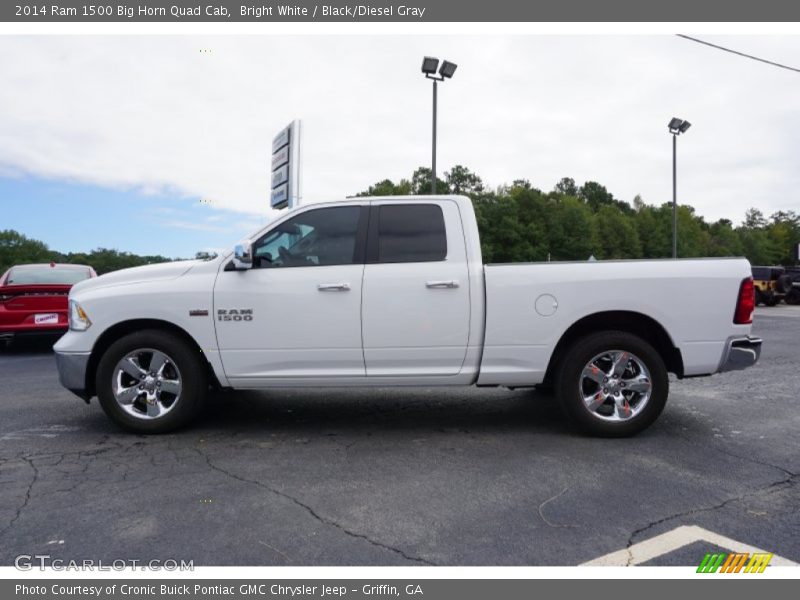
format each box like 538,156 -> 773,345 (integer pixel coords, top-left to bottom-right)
0,36 -> 800,228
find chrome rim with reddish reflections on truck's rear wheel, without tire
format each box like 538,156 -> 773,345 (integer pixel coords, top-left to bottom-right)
578,350 -> 653,421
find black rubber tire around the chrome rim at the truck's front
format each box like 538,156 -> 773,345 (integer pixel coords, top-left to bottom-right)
95,329 -> 208,433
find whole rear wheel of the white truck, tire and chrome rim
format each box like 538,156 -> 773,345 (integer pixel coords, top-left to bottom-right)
556,331 -> 669,437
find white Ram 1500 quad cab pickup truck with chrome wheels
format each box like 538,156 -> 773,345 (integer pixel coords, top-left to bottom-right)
55,196 -> 761,436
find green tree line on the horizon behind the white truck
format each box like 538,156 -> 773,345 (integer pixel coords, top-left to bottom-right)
0,165 -> 800,275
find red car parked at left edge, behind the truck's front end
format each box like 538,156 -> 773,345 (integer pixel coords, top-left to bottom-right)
0,263 -> 97,341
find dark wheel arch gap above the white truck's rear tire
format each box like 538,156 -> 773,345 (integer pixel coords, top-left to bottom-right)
544,310 -> 683,382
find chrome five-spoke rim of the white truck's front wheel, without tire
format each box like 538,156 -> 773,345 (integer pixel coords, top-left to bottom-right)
111,348 -> 182,419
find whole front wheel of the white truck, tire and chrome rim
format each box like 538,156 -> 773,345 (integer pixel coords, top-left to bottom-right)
96,330 -> 208,433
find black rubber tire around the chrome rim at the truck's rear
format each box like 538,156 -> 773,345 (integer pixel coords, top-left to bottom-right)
556,331 -> 669,437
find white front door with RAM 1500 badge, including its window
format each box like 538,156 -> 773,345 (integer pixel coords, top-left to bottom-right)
214,205 -> 368,385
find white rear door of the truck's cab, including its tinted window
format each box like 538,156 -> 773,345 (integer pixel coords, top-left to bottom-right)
362,200 -> 470,376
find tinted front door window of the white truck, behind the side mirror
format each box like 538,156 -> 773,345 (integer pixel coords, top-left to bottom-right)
253,206 -> 361,268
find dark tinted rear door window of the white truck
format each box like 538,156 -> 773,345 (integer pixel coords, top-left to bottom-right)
378,204 -> 447,263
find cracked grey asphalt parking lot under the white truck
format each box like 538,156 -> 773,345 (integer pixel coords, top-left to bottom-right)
0,306 -> 800,565
